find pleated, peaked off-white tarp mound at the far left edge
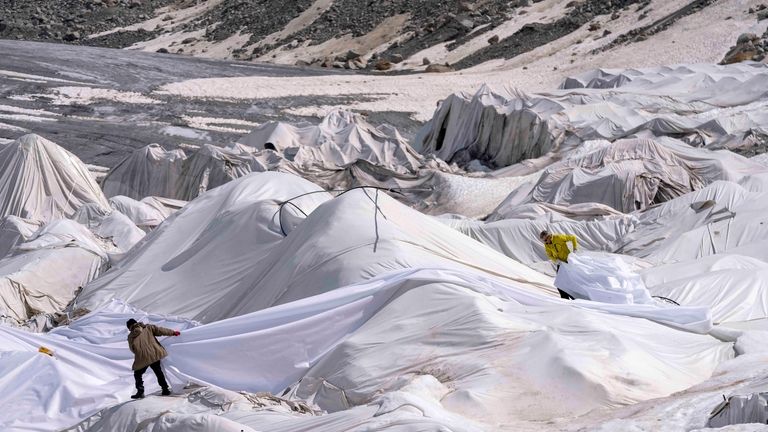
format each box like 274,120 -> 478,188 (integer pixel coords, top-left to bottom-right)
0,134 -> 109,222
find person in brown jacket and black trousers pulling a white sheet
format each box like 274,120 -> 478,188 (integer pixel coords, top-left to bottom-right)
125,318 -> 181,399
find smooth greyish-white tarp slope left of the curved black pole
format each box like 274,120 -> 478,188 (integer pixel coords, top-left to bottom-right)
78,173 -> 330,320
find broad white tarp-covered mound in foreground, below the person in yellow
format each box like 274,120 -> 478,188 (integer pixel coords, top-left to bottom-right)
296,276 -> 719,422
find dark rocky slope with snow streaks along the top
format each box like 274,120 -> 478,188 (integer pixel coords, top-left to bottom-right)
0,0 -> 766,72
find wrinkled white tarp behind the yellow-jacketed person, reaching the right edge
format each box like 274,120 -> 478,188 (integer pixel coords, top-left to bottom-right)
456,177 -> 768,269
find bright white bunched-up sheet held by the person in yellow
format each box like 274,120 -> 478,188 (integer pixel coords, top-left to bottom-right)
555,252 -> 653,304
